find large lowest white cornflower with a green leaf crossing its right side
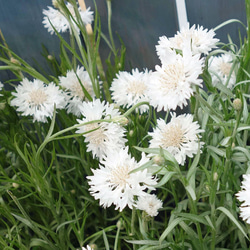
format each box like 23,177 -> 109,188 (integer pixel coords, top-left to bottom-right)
87,147 -> 157,211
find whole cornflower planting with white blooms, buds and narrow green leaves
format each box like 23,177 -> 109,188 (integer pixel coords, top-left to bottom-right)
0,0 -> 250,250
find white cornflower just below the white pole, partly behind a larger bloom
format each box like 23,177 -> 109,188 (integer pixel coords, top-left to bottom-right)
156,24 -> 219,58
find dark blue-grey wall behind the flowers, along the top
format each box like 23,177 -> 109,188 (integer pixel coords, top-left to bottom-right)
0,0 -> 246,82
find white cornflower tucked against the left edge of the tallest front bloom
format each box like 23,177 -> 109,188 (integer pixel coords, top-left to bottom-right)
110,69 -> 151,113
